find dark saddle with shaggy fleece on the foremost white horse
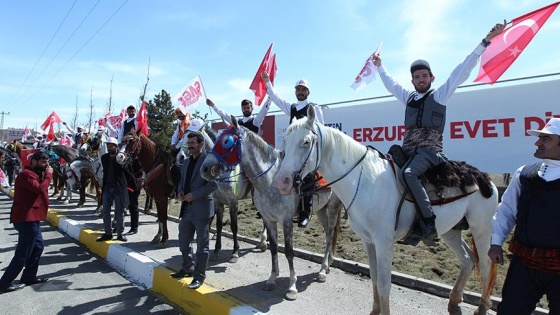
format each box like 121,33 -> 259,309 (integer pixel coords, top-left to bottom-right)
388,145 -> 480,205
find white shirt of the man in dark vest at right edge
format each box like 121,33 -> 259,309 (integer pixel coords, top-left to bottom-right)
490,159 -> 560,246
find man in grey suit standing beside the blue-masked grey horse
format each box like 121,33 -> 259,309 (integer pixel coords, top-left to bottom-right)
171,131 -> 217,289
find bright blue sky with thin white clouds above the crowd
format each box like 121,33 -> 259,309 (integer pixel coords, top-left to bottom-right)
0,0 -> 560,128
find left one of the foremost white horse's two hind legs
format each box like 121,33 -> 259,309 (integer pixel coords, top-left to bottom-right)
441,230 -> 472,315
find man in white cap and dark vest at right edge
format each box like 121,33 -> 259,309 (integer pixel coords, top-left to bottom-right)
488,118 -> 560,314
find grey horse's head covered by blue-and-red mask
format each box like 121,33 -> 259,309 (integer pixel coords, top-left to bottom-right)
201,119 -> 245,180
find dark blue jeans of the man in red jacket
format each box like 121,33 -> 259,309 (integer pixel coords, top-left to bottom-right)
0,221 -> 45,289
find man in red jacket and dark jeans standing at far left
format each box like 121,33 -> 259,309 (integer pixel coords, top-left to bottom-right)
0,152 -> 52,294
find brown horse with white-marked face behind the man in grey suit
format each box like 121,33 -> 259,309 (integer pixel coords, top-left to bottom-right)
121,130 -> 174,246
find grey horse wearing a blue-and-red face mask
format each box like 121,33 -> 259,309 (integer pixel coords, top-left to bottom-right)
200,119 -> 342,300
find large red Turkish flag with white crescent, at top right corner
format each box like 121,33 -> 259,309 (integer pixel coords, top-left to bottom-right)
474,2 -> 560,84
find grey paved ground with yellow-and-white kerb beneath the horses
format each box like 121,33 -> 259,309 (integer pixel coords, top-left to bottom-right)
0,189 -> 508,315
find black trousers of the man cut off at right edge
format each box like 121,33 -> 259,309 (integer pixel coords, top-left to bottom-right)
498,256 -> 560,315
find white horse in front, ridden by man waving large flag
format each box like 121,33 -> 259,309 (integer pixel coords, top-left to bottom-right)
275,107 -> 498,314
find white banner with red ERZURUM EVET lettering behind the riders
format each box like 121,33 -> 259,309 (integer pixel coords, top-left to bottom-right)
275,80 -> 560,173
